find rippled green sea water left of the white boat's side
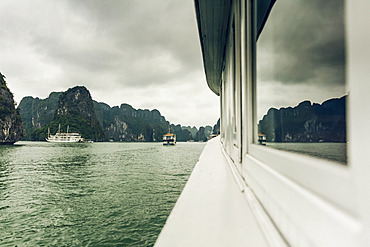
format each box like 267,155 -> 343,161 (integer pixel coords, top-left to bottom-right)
0,142 -> 204,246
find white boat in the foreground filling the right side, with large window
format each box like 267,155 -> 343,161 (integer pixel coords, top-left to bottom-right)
155,0 -> 370,247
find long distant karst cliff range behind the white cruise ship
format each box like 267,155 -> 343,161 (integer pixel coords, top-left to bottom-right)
19,87 -> 217,142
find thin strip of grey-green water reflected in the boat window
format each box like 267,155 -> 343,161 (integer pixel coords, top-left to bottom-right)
266,142 -> 347,164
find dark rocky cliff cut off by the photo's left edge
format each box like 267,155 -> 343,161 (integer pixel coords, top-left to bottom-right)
0,73 -> 24,144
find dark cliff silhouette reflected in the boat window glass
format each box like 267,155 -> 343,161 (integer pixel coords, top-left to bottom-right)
258,96 -> 346,142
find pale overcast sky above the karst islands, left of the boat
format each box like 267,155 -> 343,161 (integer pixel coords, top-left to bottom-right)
0,0 -> 219,127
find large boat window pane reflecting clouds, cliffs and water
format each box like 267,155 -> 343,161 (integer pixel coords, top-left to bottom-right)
255,0 -> 348,163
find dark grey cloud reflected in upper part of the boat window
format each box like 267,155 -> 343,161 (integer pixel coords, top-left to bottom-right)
258,0 -> 345,85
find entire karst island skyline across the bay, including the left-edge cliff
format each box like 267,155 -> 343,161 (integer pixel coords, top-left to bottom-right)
0,74 -> 219,144
